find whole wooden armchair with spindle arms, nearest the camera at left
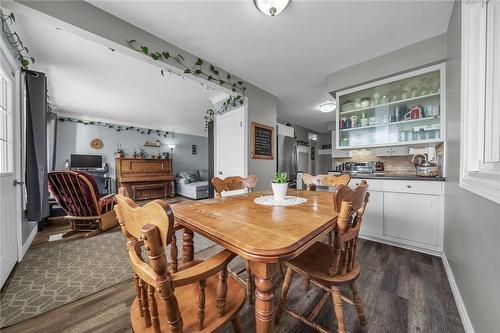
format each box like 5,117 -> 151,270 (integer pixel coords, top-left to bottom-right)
115,194 -> 245,333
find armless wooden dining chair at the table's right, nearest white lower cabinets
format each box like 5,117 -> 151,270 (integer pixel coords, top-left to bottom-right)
275,180 -> 369,333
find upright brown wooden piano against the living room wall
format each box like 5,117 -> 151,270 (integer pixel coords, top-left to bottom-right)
115,158 -> 175,201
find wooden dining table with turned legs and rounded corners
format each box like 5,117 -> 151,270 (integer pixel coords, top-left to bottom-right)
172,190 -> 337,333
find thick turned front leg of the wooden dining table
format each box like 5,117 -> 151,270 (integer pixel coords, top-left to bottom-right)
250,262 -> 277,333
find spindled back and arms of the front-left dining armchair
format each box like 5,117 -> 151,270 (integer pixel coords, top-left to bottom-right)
115,189 -> 240,333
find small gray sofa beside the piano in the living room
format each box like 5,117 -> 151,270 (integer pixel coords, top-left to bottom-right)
175,169 -> 208,199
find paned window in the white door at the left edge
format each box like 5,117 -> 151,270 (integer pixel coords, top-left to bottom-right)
0,69 -> 13,173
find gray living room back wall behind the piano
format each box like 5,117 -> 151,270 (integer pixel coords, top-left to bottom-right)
56,121 -> 208,189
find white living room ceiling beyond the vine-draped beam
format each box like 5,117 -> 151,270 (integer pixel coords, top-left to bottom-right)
15,13 -> 221,135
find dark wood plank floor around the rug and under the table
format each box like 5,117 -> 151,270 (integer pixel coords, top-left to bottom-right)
2,241 -> 464,333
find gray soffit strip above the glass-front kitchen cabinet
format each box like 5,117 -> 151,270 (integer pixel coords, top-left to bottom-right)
328,34 -> 446,94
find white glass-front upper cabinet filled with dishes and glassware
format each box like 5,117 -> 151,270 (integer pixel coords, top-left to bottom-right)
336,64 -> 446,149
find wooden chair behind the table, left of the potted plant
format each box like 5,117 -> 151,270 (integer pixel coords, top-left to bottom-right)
212,175 -> 257,304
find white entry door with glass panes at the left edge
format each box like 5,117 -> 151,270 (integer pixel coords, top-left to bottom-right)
0,48 -> 21,287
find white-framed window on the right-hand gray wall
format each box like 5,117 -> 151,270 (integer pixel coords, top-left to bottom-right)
460,0 -> 500,203
